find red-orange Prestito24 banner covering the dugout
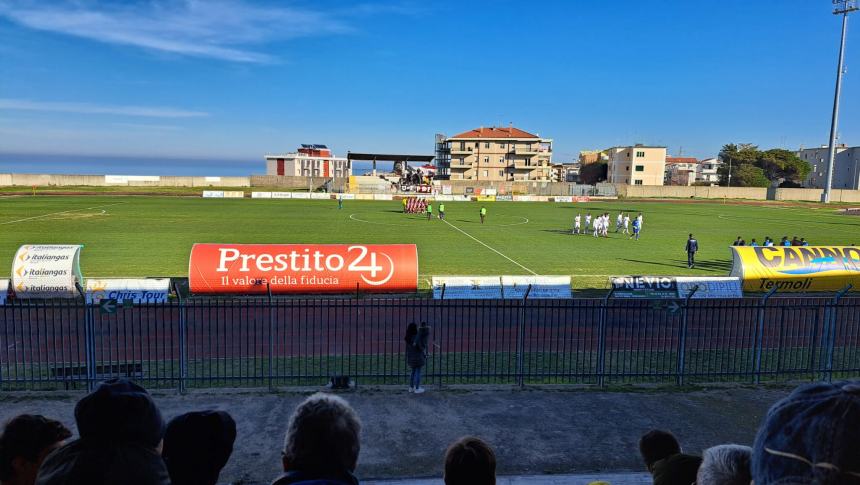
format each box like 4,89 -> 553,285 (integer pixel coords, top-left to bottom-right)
188,244 -> 418,294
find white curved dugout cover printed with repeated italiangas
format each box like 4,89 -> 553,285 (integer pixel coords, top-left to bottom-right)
12,244 -> 83,298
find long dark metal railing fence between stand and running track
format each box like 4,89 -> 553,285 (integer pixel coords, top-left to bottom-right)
0,288 -> 860,392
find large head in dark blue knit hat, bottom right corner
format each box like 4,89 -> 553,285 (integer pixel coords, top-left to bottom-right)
751,381 -> 860,485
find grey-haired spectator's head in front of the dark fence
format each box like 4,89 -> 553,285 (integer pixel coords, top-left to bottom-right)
283,393 -> 361,473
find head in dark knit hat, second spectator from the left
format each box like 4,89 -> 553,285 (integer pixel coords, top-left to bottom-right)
75,379 -> 164,449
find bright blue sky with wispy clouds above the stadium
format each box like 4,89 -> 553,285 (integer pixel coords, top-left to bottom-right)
0,0 -> 860,161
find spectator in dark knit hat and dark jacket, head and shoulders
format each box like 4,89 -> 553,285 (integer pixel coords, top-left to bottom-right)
36,379 -> 170,485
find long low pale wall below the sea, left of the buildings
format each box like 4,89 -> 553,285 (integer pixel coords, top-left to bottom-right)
0,173 -> 251,187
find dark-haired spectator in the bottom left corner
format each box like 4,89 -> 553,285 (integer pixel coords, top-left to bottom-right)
0,414 -> 72,485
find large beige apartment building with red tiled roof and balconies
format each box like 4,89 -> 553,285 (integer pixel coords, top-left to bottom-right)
443,126 -> 552,182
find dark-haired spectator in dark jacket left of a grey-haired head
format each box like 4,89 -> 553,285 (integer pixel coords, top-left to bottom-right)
639,429 -> 702,485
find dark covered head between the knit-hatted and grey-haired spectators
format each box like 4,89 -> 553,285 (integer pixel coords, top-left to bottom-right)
161,411 -> 236,485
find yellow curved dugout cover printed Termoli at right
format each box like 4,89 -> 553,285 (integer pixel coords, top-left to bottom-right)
731,246 -> 860,293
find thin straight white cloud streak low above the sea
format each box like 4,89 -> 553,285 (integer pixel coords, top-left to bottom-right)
0,98 -> 209,118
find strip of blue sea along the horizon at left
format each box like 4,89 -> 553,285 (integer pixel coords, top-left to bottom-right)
0,152 -> 392,177
